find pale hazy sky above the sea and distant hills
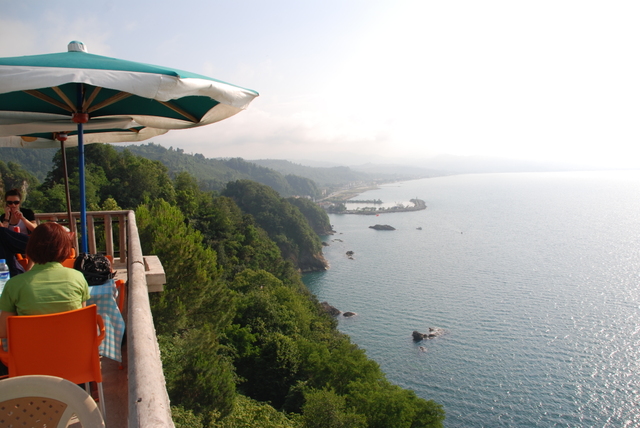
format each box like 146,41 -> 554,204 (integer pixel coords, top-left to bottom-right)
0,0 -> 640,167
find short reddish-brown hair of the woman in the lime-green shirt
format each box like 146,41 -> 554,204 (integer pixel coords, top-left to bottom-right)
27,222 -> 73,264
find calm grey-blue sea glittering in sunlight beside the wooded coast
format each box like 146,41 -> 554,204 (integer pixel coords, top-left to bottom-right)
305,171 -> 640,428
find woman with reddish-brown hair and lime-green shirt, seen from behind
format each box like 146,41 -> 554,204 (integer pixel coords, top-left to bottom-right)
0,223 -> 89,337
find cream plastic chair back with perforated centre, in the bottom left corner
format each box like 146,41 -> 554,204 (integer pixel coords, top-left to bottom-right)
0,375 -> 105,428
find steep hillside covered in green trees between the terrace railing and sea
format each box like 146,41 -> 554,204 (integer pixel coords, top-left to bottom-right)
0,144 -> 444,428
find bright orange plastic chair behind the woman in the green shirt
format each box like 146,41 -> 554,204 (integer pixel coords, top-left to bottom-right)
0,305 -> 106,419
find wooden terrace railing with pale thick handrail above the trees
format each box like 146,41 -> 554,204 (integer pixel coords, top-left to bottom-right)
36,211 -> 174,428
